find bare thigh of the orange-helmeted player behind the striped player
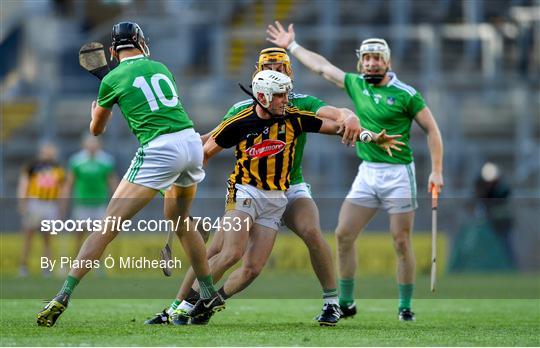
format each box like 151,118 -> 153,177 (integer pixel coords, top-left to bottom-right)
283,198 -> 320,239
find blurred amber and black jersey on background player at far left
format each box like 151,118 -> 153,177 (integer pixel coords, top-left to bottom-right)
25,160 -> 65,199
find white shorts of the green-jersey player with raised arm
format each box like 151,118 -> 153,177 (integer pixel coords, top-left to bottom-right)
346,161 -> 418,214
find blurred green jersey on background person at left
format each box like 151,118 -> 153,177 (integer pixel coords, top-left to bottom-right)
69,150 -> 114,206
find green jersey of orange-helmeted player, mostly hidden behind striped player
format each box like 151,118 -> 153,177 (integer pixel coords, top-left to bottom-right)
223,93 -> 326,185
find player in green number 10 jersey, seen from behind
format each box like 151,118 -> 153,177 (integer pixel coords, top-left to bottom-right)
37,22 -> 224,326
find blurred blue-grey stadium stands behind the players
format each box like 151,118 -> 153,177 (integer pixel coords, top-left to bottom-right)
0,0 -> 540,278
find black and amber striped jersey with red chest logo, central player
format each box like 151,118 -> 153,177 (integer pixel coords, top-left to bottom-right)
212,106 -> 323,191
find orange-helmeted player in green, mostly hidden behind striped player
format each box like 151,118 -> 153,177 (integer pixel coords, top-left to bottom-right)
146,47 -> 361,324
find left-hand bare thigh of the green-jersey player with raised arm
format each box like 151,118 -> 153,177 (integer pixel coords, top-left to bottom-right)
336,200 -> 377,239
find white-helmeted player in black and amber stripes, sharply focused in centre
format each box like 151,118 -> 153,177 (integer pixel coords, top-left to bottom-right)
150,71 -> 399,325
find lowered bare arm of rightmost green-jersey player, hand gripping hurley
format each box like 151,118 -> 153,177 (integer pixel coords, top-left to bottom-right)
415,106 -> 444,192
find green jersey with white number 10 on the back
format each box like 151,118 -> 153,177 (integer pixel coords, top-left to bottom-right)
98,55 -> 193,145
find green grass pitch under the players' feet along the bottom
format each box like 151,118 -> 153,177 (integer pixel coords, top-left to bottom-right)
0,299 -> 540,346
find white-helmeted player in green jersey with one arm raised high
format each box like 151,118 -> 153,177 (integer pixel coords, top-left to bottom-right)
266,22 -> 443,321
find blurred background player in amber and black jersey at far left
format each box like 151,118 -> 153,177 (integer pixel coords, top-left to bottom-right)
17,143 -> 65,276
